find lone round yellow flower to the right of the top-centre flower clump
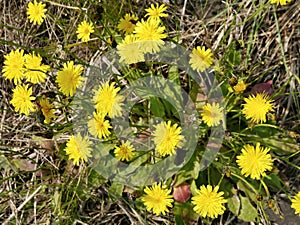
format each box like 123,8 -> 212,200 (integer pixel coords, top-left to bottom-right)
190,46 -> 214,72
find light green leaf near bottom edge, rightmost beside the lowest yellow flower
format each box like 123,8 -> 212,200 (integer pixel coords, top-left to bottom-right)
238,195 -> 258,222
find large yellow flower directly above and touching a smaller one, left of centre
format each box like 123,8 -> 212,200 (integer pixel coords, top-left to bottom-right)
93,81 -> 124,118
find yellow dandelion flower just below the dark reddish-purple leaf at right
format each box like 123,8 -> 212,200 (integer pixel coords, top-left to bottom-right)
242,93 -> 274,123
